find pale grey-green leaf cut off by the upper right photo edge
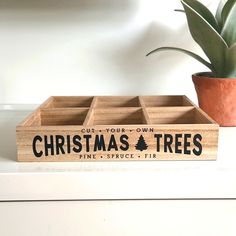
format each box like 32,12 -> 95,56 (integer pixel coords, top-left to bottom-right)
221,1 -> 236,47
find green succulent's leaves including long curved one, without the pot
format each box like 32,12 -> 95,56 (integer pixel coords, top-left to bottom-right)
147,0 -> 236,78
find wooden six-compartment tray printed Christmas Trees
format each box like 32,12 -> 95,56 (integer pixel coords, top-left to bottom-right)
16,96 -> 219,162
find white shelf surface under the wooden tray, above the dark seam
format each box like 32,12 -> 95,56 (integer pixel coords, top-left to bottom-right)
0,105 -> 236,201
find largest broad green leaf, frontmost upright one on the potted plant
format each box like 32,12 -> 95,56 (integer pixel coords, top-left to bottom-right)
181,1 -> 228,77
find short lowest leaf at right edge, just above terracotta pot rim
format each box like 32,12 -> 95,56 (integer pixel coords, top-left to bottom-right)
226,43 -> 236,78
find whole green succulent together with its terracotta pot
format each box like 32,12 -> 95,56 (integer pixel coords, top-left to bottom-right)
147,0 -> 236,126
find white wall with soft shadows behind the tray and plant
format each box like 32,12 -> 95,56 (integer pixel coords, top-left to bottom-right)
0,0 -> 215,103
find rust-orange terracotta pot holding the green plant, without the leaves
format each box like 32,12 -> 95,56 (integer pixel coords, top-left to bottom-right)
192,72 -> 236,126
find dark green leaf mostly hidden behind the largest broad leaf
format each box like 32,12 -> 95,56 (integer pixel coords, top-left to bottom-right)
182,0 -> 220,32
